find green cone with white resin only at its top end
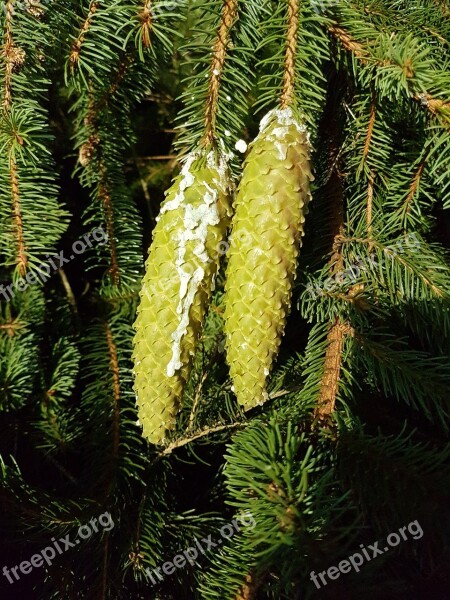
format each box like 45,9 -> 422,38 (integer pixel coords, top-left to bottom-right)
224,109 -> 313,409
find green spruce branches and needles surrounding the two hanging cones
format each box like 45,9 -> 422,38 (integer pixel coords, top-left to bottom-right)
0,0 -> 450,600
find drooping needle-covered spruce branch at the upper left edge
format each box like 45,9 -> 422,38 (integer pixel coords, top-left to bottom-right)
0,0 -> 68,277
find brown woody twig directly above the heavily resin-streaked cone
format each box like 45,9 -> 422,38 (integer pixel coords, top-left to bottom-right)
203,0 -> 238,146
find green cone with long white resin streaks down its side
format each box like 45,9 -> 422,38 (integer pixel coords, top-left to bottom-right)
133,152 -> 231,444
